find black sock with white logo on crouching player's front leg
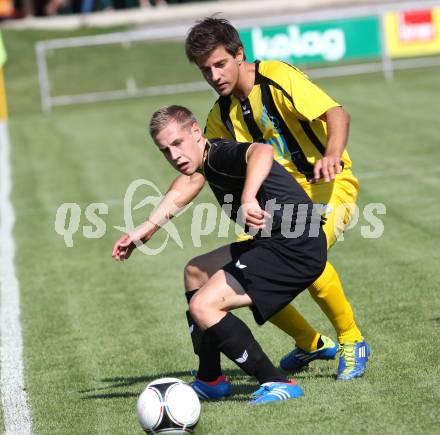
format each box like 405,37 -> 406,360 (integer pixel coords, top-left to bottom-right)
205,313 -> 288,384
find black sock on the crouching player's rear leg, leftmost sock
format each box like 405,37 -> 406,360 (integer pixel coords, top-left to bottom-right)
185,289 -> 222,382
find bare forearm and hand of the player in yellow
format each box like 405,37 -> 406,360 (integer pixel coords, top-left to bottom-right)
312,107 -> 350,183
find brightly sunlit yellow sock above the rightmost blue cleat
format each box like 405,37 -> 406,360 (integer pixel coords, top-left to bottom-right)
309,262 -> 362,343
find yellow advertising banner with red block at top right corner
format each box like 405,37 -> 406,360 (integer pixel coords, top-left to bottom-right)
385,8 -> 440,58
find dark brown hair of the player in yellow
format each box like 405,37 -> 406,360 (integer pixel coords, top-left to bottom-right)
185,17 -> 243,62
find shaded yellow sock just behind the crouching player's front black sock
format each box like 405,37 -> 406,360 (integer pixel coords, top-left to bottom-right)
269,305 -> 320,352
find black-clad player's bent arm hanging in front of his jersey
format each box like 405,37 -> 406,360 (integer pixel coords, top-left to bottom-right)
241,143 -> 273,229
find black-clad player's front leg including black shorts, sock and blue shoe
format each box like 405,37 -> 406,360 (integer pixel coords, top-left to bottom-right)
190,231 -> 326,403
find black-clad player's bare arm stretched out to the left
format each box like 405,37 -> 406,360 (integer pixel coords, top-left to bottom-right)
112,173 -> 205,261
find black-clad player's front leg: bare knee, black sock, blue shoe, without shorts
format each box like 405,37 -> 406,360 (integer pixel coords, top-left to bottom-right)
189,270 -> 303,404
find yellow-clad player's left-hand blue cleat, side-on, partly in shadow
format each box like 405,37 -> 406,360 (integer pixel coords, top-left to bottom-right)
280,335 -> 338,372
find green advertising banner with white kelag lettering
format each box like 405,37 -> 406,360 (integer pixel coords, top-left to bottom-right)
240,16 -> 381,65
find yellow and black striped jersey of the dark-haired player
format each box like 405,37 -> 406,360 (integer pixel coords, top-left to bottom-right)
205,60 -> 351,183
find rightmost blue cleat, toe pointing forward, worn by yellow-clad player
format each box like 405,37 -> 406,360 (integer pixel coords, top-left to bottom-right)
336,340 -> 370,381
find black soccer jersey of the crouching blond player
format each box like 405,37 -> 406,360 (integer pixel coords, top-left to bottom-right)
203,139 -> 320,237
